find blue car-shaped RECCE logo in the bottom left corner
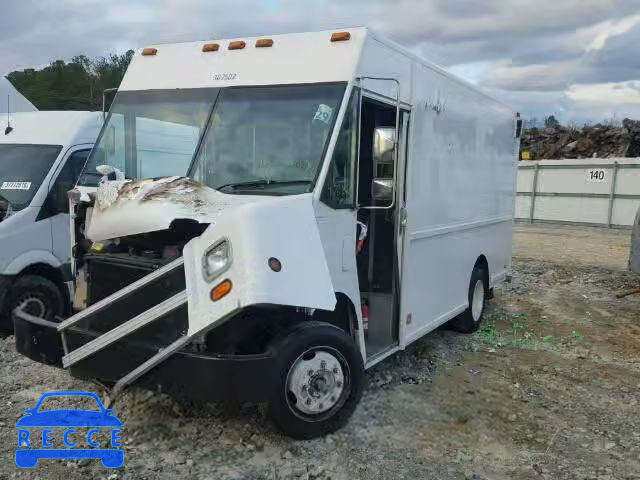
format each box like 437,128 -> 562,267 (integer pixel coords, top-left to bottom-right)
16,392 -> 124,468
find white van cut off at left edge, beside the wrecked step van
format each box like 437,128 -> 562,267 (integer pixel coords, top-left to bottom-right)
0,112 -> 102,333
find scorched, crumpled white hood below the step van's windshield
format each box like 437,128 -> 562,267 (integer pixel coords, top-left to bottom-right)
86,177 -> 264,242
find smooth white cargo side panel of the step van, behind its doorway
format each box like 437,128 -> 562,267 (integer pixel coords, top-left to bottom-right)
400,62 -> 516,344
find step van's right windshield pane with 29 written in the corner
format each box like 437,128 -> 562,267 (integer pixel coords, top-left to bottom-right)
190,84 -> 345,195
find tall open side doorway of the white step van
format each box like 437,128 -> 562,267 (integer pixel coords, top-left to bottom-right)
356,98 -> 402,360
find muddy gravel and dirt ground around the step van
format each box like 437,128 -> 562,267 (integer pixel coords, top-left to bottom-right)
0,225 -> 640,480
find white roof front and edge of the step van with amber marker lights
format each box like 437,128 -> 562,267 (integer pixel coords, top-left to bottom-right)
120,26 -> 515,112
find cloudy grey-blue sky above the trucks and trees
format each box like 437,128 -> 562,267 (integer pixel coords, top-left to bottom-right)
0,0 -> 640,123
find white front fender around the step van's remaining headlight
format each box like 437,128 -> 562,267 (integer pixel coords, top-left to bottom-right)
183,194 -> 336,335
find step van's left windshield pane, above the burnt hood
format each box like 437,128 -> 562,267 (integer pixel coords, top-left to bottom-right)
79,88 -> 218,186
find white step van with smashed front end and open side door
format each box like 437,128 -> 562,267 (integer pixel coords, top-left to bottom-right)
15,28 -> 519,438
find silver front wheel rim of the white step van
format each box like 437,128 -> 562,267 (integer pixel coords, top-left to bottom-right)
285,348 -> 348,417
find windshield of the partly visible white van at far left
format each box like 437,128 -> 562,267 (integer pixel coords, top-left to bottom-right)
0,144 -> 62,213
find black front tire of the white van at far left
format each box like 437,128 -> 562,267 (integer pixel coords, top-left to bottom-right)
1,275 -> 64,333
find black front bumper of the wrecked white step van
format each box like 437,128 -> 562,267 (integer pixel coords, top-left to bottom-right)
13,315 -> 276,403
